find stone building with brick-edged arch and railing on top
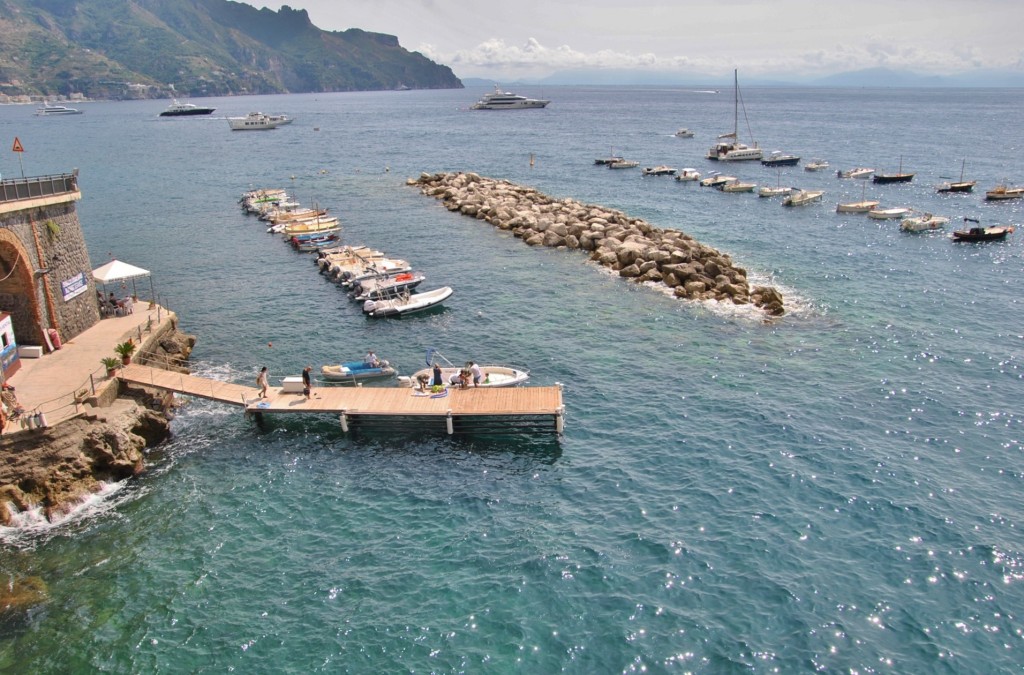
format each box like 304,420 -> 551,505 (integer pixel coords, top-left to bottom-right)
0,169 -> 100,356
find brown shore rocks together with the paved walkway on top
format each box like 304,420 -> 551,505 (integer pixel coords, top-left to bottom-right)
0,307 -> 196,526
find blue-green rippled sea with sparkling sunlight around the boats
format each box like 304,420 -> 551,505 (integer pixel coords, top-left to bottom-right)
0,83 -> 1024,674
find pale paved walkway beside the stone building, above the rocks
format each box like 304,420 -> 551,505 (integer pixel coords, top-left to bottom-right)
4,301 -> 177,432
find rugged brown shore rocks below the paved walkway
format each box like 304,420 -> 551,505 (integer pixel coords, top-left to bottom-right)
0,330 -> 196,525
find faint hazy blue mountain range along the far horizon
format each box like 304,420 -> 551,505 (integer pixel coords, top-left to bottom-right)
479,68 -> 1024,89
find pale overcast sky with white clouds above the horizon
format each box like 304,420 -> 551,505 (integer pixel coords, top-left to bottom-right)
266,0 -> 1024,79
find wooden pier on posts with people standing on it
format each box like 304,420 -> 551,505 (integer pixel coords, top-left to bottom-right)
119,364 -> 565,434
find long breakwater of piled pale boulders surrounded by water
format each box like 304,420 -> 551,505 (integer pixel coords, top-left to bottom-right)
408,172 -> 785,317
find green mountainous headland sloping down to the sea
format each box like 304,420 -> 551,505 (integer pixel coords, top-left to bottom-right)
0,0 -> 462,98
